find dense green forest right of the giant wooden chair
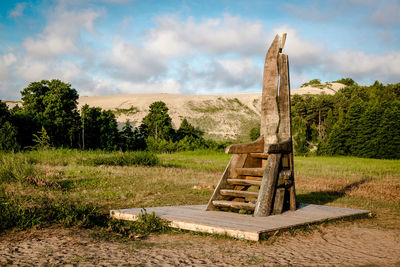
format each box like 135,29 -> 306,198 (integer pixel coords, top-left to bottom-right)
291,78 -> 400,159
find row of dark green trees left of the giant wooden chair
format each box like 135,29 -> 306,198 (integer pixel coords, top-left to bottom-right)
0,80 -> 226,152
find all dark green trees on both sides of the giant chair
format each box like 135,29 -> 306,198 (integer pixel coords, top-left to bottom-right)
0,78 -> 400,159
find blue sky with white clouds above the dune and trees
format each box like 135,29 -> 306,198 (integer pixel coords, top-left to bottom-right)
0,0 -> 400,100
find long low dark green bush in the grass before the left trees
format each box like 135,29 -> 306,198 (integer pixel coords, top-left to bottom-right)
83,151 -> 159,166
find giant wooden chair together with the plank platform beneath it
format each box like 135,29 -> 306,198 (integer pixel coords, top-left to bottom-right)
110,34 -> 370,241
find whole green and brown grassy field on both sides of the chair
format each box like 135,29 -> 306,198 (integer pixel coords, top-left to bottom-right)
0,149 -> 400,236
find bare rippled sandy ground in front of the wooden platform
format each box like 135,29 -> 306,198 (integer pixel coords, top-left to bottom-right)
0,223 -> 400,266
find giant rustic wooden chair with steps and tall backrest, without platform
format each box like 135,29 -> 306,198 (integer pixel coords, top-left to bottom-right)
207,33 -> 296,216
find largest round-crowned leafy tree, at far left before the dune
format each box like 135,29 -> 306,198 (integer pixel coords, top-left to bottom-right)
21,80 -> 80,147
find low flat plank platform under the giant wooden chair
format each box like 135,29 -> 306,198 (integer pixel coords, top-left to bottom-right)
110,204 -> 370,241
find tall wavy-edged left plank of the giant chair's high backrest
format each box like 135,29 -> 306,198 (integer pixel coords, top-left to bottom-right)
260,34 -> 286,152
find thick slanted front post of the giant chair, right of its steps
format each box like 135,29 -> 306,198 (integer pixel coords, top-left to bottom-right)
254,154 -> 282,217
